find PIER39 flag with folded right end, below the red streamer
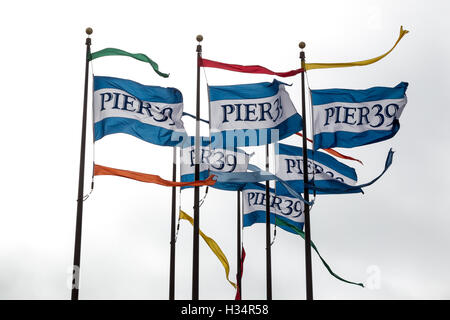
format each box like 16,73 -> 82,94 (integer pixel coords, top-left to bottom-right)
208,80 -> 302,147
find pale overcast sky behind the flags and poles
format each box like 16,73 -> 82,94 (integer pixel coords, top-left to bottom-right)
0,0 -> 450,299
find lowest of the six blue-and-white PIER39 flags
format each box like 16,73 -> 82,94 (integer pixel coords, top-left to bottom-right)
242,183 -> 305,234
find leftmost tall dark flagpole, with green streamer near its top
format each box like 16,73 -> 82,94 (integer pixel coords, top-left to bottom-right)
71,28 -> 92,300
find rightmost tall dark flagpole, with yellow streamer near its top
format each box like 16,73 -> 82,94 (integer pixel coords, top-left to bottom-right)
299,42 -> 313,300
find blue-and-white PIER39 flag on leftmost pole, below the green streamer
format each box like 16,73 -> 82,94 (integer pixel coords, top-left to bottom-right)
93,76 -> 186,146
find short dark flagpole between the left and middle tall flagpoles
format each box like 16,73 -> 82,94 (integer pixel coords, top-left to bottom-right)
169,147 -> 177,300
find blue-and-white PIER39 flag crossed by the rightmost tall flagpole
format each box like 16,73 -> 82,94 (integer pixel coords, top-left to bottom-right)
275,143 -> 362,194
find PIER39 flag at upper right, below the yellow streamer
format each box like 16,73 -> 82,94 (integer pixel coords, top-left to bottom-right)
311,82 -> 408,150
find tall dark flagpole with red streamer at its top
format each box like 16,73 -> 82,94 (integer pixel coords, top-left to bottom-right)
192,35 -> 203,300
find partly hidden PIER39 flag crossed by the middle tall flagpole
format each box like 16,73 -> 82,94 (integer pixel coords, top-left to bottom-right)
180,137 -> 250,191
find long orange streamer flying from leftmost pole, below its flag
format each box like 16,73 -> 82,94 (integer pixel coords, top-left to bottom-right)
94,164 -> 216,187
